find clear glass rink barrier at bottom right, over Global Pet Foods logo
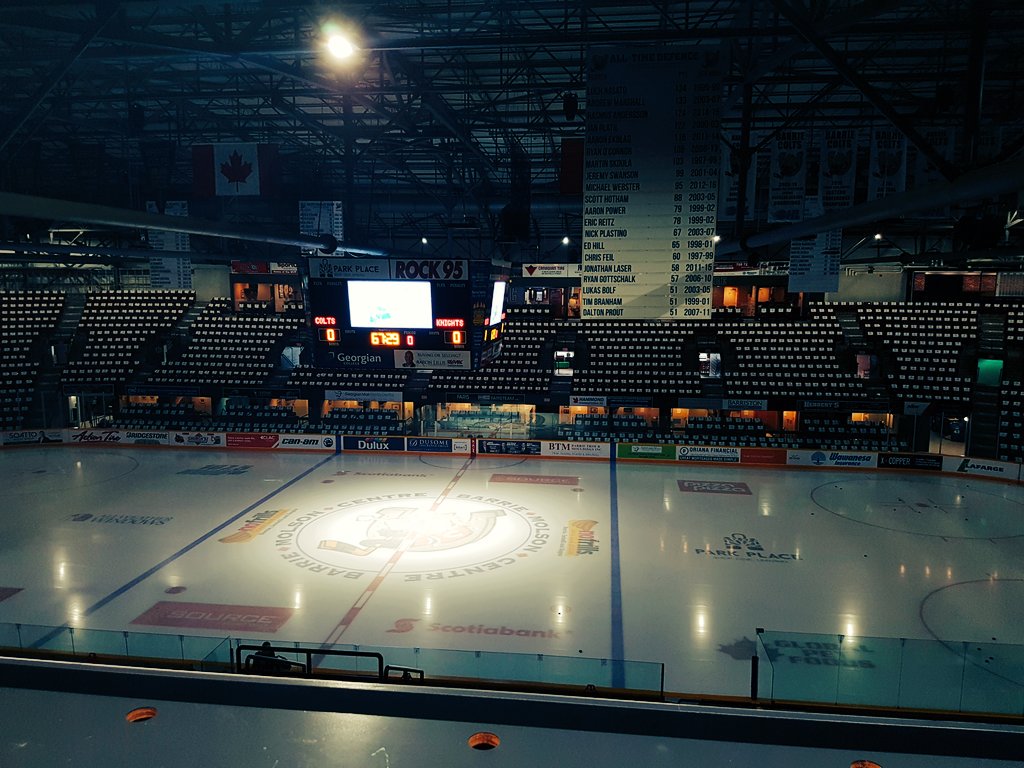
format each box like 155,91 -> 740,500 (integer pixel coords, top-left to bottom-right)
757,631 -> 1024,716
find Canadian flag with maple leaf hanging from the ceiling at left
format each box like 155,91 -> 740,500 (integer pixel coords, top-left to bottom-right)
193,143 -> 278,198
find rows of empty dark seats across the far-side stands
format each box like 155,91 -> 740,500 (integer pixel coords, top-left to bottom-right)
0,290 -> 1024,461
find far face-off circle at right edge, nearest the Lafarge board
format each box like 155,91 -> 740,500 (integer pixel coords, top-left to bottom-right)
811,477 -> 1024,539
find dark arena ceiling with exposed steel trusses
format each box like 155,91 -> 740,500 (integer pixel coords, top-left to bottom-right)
0,0 -> 1024,260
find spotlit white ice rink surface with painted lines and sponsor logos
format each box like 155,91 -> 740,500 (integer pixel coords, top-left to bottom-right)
0,446 -> 1024,696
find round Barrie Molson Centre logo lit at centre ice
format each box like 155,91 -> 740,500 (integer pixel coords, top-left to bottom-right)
275,493 -> 551,582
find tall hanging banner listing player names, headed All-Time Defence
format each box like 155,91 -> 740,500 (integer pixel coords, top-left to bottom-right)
581,48 -> 722,319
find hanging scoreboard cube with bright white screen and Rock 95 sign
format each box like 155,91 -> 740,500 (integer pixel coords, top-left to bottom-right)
309,258 -> 506,371
